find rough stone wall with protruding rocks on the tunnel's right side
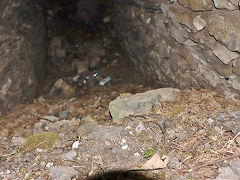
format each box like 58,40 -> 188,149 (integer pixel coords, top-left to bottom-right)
113,0 -> 240,99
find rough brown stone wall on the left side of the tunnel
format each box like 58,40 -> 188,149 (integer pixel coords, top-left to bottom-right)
0,0 -> 47,114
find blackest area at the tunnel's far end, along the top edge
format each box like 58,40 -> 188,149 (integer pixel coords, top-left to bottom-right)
47,0 -> 110,31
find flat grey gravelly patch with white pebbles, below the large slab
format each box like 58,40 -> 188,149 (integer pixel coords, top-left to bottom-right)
76,119 -> 163,175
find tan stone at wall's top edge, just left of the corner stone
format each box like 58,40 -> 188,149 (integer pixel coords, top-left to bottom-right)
178,0 -> 214,11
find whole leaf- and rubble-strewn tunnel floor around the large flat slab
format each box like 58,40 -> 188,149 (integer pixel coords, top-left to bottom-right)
0,17 -> 240,179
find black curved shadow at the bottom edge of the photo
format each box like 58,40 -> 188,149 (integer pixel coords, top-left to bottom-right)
87,171 -> 158,180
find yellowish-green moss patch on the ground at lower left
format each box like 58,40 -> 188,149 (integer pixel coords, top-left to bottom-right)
24,132 -> 58,151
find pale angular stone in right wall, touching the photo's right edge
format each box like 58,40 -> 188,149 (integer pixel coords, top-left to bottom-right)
213,45 -> 239,64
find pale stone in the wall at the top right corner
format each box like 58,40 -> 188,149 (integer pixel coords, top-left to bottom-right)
213,0 -> 239,11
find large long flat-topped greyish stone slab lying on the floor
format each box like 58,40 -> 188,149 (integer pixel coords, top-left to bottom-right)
109,88 -> 180,121
